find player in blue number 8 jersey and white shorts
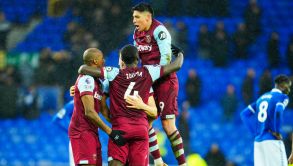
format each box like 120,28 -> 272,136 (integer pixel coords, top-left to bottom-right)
241,75 -> 291,166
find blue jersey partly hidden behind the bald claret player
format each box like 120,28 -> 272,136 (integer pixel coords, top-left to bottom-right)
53,100 -> 74,132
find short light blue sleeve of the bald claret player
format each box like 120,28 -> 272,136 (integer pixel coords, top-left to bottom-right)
77,75 -> 95,96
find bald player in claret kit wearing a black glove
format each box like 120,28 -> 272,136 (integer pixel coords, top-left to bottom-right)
68,48 -> 125,166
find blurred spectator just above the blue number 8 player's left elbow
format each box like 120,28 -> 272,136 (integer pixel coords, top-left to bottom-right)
242,68 -> 255,105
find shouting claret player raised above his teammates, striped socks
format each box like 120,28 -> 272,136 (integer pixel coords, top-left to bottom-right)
132,3 -> 186,165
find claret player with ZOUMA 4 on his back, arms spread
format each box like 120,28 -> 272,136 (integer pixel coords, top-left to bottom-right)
80,45 -> 183,165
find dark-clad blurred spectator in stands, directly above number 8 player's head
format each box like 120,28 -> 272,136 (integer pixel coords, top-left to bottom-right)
267,32 -> 280,68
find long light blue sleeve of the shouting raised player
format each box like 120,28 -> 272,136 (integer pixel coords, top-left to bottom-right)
154,25 -> 172,65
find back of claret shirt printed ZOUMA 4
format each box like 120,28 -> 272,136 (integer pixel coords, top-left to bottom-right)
109,67 -> 153,125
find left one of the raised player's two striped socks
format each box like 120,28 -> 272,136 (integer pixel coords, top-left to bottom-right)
149,127 -> 163,165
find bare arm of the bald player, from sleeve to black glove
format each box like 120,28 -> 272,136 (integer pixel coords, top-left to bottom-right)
81,95 -> 112,135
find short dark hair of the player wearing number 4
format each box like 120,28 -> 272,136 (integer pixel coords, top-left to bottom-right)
120,44 -> 138,65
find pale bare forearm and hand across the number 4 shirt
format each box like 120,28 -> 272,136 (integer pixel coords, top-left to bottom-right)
125,95 -> 157,118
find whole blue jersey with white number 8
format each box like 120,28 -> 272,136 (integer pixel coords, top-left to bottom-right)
241,89 -> 289,142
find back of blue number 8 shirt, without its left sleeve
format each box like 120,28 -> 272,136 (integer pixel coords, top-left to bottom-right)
255,89 -> 287,142
